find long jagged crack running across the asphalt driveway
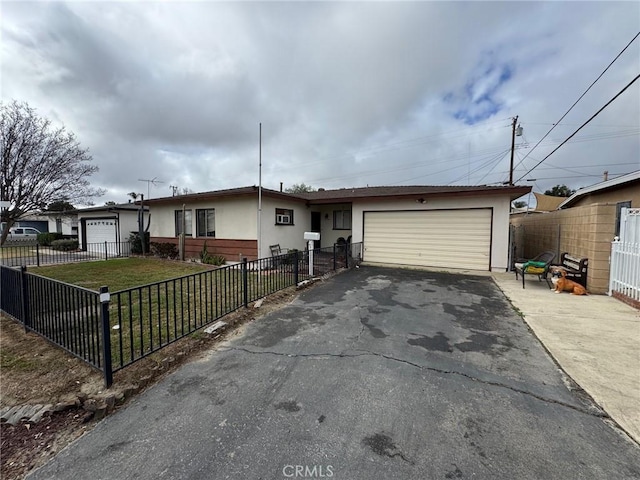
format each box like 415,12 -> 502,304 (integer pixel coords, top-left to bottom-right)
220,344 -> 609,418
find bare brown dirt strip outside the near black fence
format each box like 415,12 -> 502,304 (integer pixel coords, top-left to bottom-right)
0,287 -> 298,479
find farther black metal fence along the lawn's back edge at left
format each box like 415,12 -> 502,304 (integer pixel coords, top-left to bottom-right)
0,242 -> 131,267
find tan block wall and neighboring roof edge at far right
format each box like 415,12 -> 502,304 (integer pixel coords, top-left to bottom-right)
511,170 -> 640,293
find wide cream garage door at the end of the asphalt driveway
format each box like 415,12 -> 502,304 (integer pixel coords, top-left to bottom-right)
363,209 -> 492,271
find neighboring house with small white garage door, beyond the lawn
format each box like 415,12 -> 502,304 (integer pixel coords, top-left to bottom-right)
76,203 -> 149,250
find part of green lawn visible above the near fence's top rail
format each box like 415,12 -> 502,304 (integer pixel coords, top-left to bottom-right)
28,258 -> 208,292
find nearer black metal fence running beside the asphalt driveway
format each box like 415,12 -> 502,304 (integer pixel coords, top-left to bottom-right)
0,243 -> 362,386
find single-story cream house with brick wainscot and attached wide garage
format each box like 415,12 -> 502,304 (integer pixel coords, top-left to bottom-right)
145,186 -> 531,271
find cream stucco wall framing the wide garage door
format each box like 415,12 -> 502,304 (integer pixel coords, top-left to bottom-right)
352,195 -> 511,271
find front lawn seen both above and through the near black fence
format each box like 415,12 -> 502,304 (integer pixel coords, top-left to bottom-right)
22,258 -> 295,370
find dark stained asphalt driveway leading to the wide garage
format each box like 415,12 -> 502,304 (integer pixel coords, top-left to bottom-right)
30,267 -> 640,480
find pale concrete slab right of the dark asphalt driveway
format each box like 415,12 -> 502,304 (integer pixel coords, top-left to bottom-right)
492,273 -> 640,443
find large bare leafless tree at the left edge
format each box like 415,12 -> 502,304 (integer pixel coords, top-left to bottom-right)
0,101 -> 103,245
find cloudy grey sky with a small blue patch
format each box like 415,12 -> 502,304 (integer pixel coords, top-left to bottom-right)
0,0 -> 640,204
